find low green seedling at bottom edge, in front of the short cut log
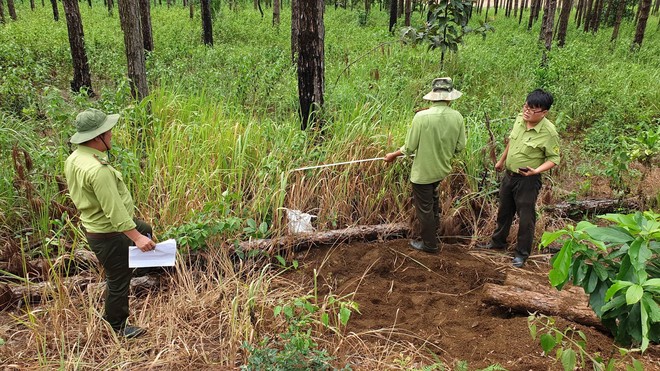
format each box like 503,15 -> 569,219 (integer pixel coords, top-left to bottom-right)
527,314 -> 643,371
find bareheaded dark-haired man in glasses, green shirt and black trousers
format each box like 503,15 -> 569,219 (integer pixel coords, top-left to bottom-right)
481,89 -> 559,268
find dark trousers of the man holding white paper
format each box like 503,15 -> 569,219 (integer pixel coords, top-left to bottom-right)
87,219 -> 152,330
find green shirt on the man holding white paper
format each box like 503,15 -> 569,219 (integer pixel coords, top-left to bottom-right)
64,146 -> 135,233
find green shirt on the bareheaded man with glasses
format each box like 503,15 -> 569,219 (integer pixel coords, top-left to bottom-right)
505,114 -> 559,172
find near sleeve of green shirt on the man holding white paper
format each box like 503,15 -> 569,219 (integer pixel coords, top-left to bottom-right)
92,167 -> 136,232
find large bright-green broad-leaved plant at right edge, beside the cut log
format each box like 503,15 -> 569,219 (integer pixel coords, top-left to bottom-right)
541,211 -> 660,352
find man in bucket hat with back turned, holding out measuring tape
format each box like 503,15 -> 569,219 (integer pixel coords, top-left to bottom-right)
385,77 -> 465,253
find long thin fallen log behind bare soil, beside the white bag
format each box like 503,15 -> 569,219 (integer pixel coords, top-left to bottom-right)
238,223 -> 410,254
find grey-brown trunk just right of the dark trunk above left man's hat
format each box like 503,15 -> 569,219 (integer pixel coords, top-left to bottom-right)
118,0 -> 149,100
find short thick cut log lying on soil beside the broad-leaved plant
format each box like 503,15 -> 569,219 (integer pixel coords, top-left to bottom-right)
483,283 -> 606,331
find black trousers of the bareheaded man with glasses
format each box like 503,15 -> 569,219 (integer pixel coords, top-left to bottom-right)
492,172 -> 541,259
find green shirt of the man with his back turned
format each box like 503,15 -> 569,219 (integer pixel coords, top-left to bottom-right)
401,102 -> 465,184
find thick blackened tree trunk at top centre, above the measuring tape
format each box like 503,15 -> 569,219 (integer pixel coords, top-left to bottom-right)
298,0 -> 324,130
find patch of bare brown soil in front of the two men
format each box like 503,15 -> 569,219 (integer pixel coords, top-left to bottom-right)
292,240 -> 660,370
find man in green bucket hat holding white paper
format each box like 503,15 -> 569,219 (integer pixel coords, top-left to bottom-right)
64,108 -> 156,338
